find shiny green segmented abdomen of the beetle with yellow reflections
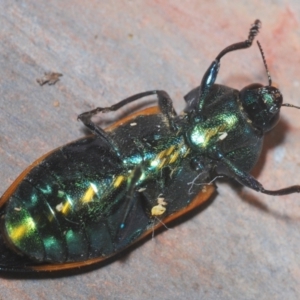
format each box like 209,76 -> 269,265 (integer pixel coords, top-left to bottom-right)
3,138 -> 131,262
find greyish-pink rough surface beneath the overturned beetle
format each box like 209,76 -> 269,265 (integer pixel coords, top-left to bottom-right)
0,0 -> 300,299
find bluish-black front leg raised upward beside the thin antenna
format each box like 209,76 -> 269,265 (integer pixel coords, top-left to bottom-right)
196,20 -> 261,115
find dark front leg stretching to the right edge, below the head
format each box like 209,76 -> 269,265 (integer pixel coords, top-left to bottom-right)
214,147 -> 300,196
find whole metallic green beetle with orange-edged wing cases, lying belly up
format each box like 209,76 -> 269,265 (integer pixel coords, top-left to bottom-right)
0,20 -> 300,271
